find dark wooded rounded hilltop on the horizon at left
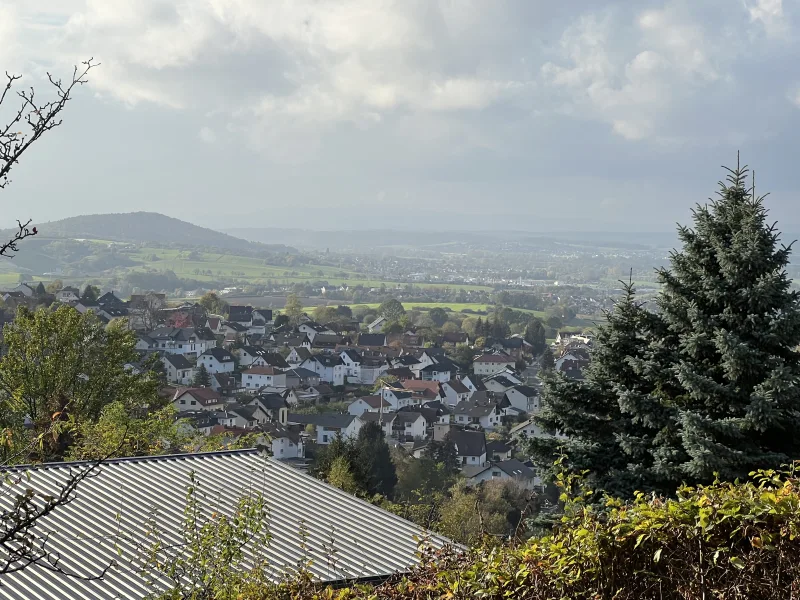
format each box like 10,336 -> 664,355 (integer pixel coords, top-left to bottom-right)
20,212 -> 297,253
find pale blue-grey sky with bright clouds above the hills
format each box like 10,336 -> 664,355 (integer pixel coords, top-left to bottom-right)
0,0 -> 800,231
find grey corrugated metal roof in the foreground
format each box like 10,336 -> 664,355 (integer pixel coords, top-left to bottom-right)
0,450 -> 448,600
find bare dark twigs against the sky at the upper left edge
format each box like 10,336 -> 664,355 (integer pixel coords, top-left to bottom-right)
0,58 -> 99,258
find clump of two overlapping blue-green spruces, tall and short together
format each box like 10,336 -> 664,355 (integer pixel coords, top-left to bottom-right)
533,167 -> 800,496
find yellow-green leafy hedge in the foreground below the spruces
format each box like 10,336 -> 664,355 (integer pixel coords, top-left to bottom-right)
234,467 -> 800,600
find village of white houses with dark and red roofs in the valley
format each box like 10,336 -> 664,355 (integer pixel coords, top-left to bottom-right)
3,284 -> 593,489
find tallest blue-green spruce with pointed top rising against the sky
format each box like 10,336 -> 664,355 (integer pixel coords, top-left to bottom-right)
643,165 -> 800,483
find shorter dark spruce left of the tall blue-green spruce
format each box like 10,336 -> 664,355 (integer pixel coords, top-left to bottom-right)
529,283 -> 665,496
